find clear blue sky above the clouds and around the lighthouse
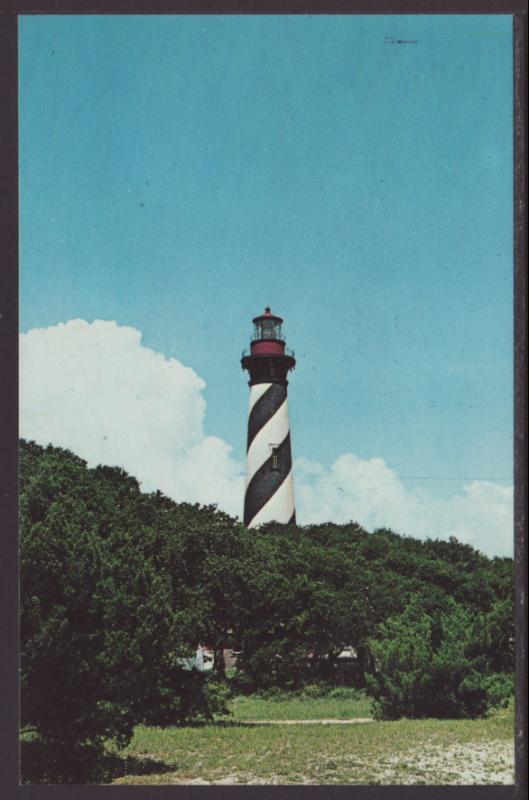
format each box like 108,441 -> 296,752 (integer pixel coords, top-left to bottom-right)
20,16 -> 513,528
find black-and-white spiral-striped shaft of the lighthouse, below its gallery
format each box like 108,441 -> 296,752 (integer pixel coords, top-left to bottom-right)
244,383 -> 295,528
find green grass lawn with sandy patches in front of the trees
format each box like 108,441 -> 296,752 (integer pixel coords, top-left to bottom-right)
107,697 -> 514,784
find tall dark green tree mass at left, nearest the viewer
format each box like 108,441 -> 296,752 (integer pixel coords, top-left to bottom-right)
20,443 -> 232,779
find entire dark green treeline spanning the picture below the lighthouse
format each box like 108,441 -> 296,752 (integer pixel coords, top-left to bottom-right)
20,441 -> 514,780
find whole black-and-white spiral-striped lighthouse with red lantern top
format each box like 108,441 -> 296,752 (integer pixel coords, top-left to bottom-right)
241,307 -> 296,528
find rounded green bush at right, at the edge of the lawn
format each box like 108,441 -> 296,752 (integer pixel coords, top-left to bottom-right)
367,600 -> 513,719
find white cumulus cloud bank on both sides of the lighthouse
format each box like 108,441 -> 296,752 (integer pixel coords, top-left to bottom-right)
20,320 -> 513,555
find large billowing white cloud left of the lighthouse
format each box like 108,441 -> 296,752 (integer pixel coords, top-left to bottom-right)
20,319 -> 244,515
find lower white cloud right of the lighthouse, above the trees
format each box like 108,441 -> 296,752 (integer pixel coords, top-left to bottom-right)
294,453 -> 513,556
